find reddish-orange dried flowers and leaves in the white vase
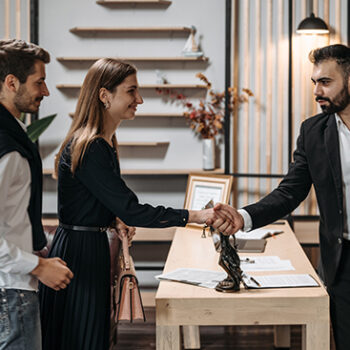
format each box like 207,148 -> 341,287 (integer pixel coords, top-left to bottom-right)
156,73 -> 254,139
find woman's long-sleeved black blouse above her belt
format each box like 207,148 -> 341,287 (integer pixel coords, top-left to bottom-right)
58,138 -> 188,228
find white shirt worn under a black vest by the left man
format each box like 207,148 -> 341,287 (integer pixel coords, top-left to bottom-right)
0,119 -> 39,290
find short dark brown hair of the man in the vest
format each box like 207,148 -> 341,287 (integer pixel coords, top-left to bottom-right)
0,39 -> 50,88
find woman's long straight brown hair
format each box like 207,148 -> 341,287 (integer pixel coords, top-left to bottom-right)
55,58 -> 136,175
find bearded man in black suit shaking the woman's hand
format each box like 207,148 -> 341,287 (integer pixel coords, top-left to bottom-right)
211,45 -> 350,350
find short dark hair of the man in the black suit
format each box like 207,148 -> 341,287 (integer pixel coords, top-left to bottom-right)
309,44 -> 350,78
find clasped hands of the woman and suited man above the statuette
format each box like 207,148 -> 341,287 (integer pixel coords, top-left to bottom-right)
188,203 -> 244,236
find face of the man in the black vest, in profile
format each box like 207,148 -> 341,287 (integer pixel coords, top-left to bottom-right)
13,60 -> 49,113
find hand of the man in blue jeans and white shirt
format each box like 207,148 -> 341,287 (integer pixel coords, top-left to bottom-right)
31,258 -> 73,291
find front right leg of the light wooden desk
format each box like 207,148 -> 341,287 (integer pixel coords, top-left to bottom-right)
301,321 -> 330,350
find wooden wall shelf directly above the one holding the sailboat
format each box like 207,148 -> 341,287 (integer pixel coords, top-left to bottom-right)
69,27 -> 192,34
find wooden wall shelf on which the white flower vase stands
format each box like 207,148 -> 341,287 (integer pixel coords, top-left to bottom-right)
43,168 -> 224,175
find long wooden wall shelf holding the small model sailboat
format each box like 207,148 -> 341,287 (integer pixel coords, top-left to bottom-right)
56,56 -> 209,63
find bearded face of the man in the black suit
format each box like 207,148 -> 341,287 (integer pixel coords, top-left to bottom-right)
311,60 -> 350,113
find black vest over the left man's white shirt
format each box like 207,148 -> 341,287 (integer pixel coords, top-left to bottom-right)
0,104 -> 46,250
